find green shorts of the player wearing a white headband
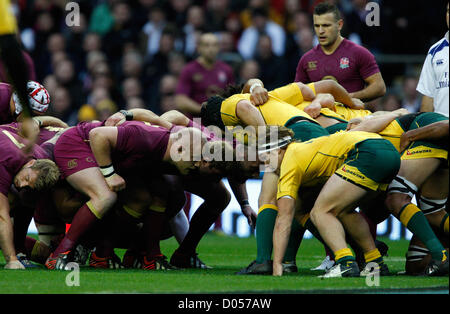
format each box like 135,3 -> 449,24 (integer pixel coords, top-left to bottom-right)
335,139 -> 400,191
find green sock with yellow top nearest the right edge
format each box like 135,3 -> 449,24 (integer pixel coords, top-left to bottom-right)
399,203 -> 445,261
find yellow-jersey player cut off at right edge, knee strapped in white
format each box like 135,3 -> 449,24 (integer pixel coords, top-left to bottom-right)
349,112 -> 449,275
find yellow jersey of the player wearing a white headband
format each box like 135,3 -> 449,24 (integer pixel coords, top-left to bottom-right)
277,131 -> 381,199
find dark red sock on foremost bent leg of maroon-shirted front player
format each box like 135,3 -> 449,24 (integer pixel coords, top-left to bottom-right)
53,204 -> 98,256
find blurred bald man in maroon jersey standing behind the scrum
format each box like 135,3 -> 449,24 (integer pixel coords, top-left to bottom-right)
175,33 -> 235,117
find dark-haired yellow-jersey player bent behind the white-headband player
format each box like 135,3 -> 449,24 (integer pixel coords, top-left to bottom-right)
202,79 -> 336,274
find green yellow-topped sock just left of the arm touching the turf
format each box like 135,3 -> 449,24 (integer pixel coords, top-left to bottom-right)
256,204 -> 278,263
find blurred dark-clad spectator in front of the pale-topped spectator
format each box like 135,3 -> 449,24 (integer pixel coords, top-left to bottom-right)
255,34 -> 291,90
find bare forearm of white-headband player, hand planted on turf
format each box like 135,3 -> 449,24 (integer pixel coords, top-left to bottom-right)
273,197 -> 295,276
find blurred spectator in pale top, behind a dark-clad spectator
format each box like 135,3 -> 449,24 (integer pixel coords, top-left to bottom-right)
238,8 -> 286,59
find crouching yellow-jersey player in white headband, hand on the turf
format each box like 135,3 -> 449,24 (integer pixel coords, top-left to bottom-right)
258,128 -> 400,278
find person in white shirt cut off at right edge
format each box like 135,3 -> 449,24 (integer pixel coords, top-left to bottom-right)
417,3 -> 449,117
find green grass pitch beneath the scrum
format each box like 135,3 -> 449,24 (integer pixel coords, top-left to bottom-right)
0,234 -> 449,294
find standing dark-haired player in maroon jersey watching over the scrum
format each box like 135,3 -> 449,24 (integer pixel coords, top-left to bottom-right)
295,2 -> 386,102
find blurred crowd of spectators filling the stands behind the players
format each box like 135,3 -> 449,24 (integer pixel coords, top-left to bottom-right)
1,0 -> 446,125
